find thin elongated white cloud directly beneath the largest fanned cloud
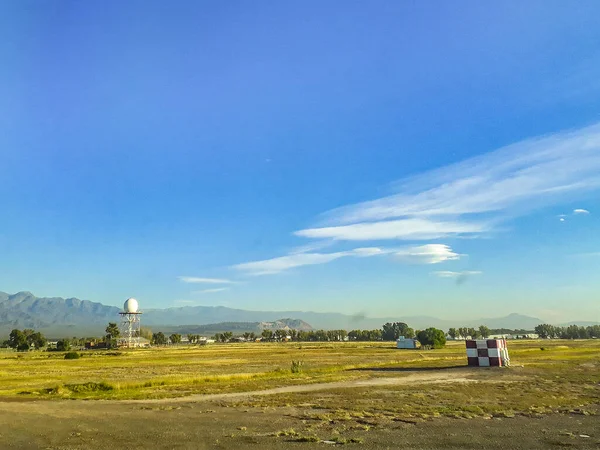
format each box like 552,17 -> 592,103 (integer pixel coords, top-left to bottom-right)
233,244 -> 461,275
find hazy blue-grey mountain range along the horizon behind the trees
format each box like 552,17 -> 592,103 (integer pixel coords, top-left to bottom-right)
0,292 -> 594,337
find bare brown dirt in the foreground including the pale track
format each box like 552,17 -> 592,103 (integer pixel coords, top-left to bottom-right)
0,371 -> 600,450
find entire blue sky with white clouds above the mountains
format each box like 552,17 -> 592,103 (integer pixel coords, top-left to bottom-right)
0,0 -> 600,322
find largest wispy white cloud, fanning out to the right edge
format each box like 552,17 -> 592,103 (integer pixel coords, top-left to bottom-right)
295,124 -> 600,241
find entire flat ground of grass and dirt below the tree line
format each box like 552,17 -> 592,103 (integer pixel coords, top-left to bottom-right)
0,340 -> 600,449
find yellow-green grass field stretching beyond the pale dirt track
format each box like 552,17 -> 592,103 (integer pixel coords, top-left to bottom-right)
0,340 -> 600,413
